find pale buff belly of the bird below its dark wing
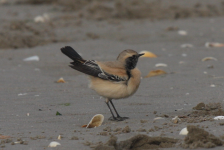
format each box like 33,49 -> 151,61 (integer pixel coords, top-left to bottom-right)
89,77 -> 140,99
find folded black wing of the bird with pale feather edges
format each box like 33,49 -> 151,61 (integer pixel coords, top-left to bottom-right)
70,60 -> 127,82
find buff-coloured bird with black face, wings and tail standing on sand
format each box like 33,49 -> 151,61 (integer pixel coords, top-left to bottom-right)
61,46 -> 144,121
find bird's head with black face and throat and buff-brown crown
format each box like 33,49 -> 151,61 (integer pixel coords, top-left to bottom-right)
117,49 -> 144,70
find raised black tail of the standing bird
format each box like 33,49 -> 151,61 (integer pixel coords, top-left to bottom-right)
61,46 -> 83,62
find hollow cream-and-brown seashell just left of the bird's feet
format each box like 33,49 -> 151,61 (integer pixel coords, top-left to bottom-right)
82,114 -> 104,128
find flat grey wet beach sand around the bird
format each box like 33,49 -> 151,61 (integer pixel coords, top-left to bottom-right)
0,0 -> 224,150
